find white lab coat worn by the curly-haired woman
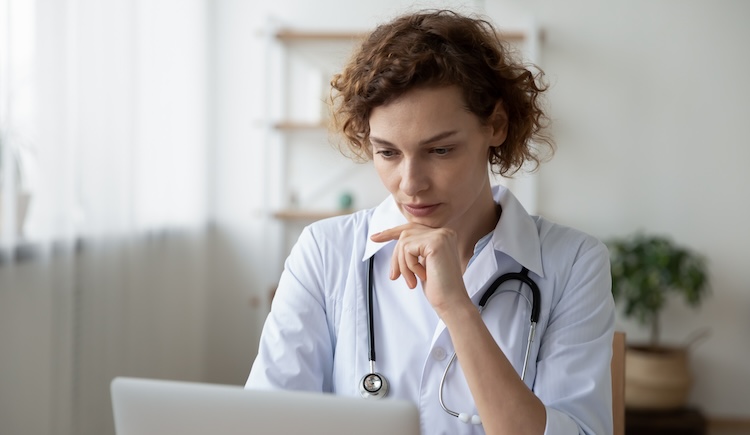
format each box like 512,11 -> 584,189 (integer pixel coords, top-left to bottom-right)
246,187 -> 614,435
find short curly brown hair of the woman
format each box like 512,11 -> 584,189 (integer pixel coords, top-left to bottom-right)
331,10 -> 554,175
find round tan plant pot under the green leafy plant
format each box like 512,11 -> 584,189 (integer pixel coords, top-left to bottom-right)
625,346 -> 693,410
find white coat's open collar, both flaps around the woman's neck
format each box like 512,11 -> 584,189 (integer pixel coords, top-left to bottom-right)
362,186 -> 544,276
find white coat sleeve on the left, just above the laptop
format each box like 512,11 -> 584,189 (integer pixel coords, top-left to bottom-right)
245,227 -> 333,392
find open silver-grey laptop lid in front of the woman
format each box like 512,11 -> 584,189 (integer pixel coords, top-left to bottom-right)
111,377 -> 419,435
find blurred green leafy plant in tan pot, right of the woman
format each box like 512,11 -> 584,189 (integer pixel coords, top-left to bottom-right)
606,233 -> 709,409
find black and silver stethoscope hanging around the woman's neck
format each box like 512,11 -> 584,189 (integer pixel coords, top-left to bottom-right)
359,255 -> 541,424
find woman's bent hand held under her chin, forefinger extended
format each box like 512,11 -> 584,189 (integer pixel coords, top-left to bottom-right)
371,223 -> 471,317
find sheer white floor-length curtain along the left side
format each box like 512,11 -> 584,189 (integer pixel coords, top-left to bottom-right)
0,0 -> 213,435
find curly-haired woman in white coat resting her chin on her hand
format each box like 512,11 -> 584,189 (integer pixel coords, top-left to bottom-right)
247,11 -> 614,434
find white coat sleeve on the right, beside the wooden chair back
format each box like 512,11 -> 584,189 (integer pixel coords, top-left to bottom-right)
534,237 -> 615,435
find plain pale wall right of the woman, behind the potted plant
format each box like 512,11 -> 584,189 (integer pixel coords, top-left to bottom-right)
532,1 -> 750,416
